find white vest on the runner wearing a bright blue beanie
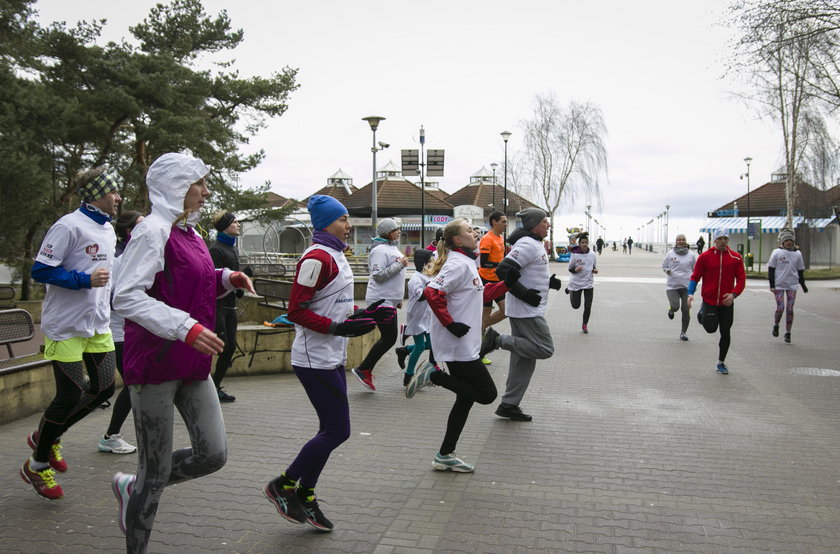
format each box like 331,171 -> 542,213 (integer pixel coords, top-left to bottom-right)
292,244 -> 353,369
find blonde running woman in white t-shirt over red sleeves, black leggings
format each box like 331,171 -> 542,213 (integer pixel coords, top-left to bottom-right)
406,219 -> 507,473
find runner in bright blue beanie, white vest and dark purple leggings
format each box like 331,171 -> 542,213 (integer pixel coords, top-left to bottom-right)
263,194 -> 388,531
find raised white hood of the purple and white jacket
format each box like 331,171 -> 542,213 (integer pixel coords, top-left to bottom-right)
146,152 -> 210,226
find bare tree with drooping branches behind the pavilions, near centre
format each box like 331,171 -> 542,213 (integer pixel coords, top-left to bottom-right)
521,93 -> 607,242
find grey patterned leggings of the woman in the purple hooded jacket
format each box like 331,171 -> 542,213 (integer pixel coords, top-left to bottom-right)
125,377 -> 227,553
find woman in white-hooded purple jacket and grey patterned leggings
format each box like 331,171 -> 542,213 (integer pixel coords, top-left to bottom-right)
111,153 -> 254,553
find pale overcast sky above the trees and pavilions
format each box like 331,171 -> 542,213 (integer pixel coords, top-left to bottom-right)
35,0 -> 783,242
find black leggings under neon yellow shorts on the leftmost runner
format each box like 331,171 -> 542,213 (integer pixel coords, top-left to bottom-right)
33,351 -> 114,462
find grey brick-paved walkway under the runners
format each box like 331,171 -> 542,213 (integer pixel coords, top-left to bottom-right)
0,250 -> 840,554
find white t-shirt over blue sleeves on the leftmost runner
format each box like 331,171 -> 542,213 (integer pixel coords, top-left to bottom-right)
35,210 -> 117,341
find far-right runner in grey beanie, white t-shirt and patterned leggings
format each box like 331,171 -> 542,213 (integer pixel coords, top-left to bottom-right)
767,229 -> 808,342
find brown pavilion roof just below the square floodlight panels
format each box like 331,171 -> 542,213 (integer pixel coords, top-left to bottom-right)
342,178 -> 452,217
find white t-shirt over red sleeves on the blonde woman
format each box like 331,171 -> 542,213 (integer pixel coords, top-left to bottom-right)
429,251 -> 484,362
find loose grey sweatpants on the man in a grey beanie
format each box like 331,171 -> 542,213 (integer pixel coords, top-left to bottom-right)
499,316 -> 554,406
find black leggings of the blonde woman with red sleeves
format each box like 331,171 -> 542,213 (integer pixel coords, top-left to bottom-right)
431,360 -> 498,456
